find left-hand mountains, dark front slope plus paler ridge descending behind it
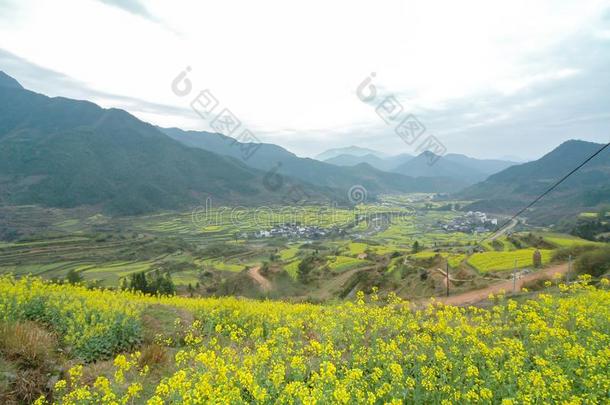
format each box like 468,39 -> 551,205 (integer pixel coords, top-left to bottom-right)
0,72 -> 459,214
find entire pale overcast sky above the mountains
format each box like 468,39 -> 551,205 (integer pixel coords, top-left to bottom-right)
0,0 -> 610,160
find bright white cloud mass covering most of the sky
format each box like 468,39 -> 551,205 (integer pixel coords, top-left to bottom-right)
0,0 -> 608,154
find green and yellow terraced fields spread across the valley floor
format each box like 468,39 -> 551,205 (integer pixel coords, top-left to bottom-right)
0,201 -> 604,294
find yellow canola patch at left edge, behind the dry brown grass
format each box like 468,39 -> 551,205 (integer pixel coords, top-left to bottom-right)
0,276 -> 141,361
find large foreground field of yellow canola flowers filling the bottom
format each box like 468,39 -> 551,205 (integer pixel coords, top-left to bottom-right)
2,274 -> 610,404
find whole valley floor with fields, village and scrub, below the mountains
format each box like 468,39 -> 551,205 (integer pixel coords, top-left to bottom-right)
0,193 -> 604,301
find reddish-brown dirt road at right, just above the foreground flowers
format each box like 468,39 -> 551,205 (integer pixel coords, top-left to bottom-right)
436,263 -> 568,306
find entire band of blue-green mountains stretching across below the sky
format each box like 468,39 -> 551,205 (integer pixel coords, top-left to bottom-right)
0,72 -> 610,218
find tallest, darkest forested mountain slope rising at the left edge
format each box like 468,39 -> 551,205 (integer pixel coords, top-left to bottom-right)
0,75 -> 332,214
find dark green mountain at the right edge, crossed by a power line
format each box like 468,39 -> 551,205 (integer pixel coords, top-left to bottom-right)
457,140 -> 610,222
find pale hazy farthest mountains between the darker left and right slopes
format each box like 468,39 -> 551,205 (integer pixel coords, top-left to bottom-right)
318,147 -> 517,185
